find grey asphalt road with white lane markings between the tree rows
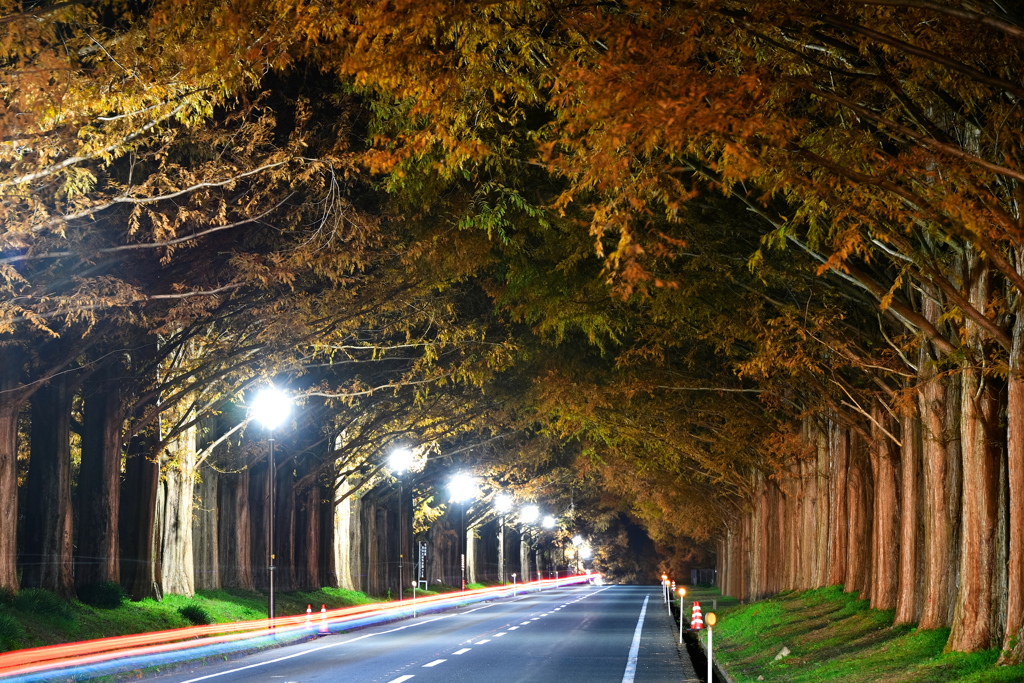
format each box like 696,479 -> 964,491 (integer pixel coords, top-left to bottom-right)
151,585 -> 689,683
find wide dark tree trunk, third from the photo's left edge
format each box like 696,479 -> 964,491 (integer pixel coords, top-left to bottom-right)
75,364 -> 124,588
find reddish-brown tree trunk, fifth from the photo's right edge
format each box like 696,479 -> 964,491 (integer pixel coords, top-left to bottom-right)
870,403 -> 900,609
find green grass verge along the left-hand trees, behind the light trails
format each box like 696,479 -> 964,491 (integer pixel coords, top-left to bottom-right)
0,588 -> 379,651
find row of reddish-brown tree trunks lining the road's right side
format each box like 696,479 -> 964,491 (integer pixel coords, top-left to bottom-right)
719,342 -> 1024,661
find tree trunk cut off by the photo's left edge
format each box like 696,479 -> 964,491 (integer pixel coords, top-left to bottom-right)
0,346 -> 27,591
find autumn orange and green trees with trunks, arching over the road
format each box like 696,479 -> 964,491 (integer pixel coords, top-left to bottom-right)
0,0 -> 1024,663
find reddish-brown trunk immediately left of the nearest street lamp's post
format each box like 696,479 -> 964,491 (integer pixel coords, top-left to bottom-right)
217,469 -> 255,591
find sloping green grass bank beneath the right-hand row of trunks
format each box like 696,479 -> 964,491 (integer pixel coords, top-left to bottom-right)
701,587 -> 1024,683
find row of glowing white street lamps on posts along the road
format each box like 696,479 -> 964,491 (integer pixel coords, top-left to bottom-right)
249,385 -> 591,627
